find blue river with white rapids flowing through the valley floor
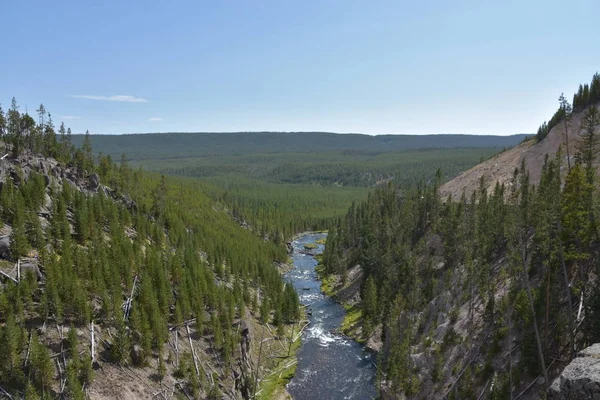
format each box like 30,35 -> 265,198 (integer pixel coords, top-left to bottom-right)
286,234 -> 377,400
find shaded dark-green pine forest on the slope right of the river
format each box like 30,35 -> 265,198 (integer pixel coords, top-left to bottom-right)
323,75 -> 600,399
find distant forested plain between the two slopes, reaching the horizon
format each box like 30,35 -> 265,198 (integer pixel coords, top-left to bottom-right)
73,132 -> 525,242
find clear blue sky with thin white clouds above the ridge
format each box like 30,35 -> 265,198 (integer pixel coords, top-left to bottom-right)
0,0 -> 600,134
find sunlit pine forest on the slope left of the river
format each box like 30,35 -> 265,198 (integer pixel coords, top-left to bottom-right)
0,99 -> 300,399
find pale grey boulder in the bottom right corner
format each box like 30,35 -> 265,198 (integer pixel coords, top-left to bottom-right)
548,343 -> 600,400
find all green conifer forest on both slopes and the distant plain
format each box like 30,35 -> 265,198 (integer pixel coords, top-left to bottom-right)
0,78 -> 600,399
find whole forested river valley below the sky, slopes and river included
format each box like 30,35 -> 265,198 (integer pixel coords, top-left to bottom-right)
0,72 -> 600,399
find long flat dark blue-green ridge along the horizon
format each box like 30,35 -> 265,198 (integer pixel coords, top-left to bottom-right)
73,132 -> 528,160
